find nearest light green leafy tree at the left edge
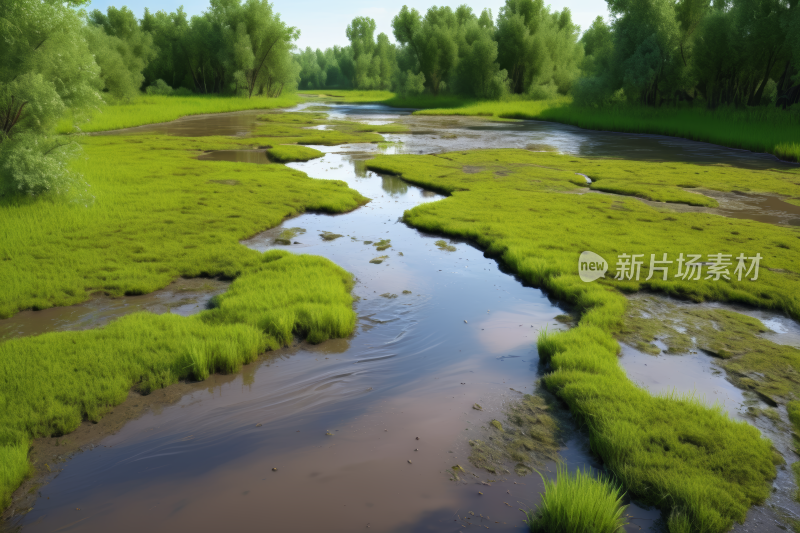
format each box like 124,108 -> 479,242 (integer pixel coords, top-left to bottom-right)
0,0 -> 102,196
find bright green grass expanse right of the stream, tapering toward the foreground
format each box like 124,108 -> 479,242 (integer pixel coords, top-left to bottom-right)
367,150 -> 800,532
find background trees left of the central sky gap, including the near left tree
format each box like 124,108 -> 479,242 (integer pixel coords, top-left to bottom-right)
0,0 -> 300,196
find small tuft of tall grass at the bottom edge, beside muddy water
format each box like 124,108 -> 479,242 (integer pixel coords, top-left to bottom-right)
525,463 -> 627,533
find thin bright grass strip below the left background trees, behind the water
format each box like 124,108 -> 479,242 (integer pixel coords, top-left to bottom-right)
56,94 -> 301,133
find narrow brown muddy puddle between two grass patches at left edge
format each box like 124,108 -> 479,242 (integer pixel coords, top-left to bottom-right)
0,278 -> 230,340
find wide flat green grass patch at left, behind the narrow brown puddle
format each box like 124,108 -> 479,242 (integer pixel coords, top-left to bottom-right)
0,109 -> 400,317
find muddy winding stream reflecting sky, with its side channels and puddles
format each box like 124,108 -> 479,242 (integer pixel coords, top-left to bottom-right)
0,105 -> 800,532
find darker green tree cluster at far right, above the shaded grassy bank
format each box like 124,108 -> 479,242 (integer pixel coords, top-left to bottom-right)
574,0 -> 800,108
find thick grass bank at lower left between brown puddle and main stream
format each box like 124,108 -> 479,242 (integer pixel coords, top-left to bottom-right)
0,250 -> 356,507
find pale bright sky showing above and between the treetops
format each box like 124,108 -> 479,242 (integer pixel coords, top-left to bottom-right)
88,0 -> 608,49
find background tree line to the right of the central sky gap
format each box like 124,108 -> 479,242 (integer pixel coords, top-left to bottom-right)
295,0 -> 800,108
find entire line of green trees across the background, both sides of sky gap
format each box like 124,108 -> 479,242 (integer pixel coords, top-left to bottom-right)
0,0 -> 800,196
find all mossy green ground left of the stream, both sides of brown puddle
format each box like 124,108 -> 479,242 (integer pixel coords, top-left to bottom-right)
0,105 -> 404,508
